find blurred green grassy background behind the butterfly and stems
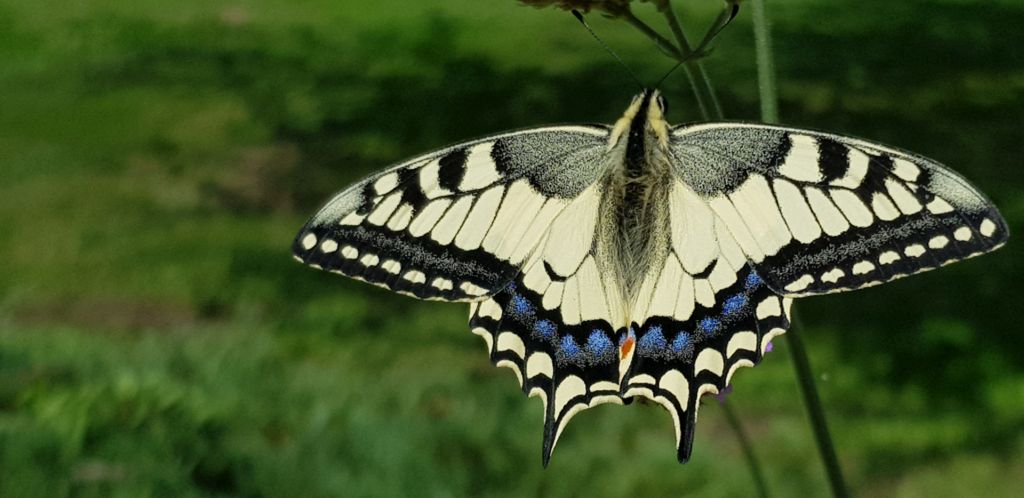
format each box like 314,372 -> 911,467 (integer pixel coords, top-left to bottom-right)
0,0 -> 1024,497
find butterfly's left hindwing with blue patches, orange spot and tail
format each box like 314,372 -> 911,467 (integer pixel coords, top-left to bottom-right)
470,186 -> 626,465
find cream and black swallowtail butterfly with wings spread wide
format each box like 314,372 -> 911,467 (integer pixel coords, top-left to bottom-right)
293,90 -> 1009,465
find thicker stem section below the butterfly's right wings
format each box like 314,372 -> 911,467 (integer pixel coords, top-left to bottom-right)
785,315 -> 850,498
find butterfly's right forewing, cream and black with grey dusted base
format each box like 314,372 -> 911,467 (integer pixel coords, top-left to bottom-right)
671,123 -> 1009,296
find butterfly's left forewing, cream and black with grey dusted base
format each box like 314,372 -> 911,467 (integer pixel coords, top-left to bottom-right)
292,126 -> 607,301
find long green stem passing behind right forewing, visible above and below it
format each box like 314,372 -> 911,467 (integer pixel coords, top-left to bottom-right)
751,0 -> 850,498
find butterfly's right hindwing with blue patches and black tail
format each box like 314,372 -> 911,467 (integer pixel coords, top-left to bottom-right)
623,181 -> 792,461
